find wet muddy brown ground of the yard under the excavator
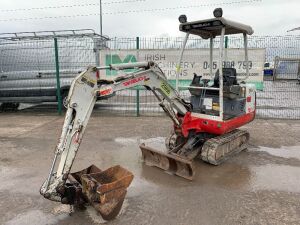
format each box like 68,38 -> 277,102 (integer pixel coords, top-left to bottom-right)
0,112 -> 300,225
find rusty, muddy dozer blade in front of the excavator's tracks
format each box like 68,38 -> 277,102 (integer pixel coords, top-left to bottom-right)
140,144 -> 195,180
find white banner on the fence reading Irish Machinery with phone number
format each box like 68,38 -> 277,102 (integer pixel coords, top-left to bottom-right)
100,48 -> 265,89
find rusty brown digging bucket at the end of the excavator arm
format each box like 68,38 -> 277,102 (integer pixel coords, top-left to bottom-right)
71,165 -> 133,220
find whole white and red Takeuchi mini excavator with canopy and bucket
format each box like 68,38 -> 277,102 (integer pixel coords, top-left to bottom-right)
40,8 -> 256,220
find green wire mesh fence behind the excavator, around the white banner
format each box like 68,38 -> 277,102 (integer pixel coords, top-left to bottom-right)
0,36 -> 300,119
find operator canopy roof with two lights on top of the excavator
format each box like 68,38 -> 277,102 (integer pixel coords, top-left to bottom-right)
179,9 -> 254,39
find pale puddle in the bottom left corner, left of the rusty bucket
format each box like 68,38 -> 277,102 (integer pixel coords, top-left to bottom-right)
5,210 -> 68,225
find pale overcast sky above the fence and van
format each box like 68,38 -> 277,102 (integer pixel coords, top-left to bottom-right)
0,0 -> 300,37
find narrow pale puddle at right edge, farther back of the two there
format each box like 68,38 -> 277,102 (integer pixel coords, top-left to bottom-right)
258,146 -> 300,159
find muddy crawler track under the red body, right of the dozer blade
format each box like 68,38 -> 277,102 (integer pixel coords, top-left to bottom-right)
201,129 -> 249,165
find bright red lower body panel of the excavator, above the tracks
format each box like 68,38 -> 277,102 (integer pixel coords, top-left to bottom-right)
181,111 -> 255,137
